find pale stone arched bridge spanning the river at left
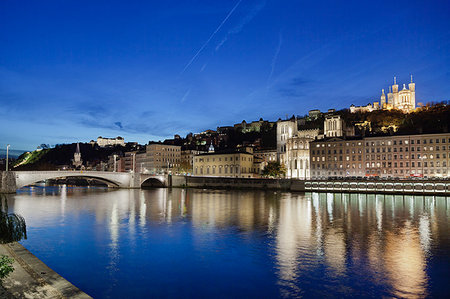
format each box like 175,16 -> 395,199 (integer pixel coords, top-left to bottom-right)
0,171 -> 172,192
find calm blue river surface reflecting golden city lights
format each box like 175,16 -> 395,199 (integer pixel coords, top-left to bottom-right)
8,186 -> 450,298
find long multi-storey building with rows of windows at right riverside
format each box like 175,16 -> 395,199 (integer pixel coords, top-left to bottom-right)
310,133 -> 450,179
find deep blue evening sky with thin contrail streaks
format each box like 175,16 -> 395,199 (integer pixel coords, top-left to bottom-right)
0,0 -> 450,149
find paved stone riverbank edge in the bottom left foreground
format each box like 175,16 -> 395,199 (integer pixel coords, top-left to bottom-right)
0,243 -> 91,299
